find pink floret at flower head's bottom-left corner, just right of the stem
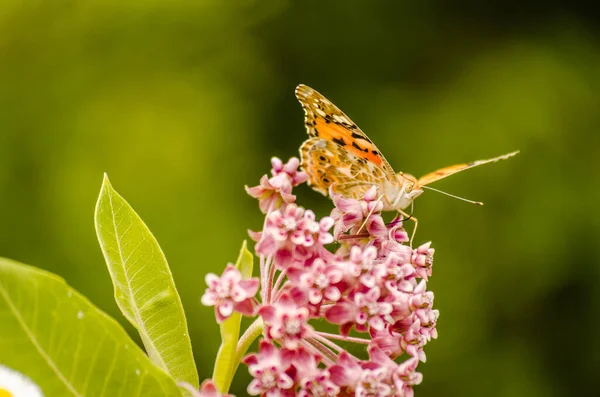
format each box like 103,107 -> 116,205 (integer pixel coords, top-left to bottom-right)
243,340 -> 295,397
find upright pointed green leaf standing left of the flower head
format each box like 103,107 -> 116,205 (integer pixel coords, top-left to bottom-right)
95,175 -> 198,394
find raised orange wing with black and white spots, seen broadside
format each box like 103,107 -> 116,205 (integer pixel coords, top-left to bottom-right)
296,85 -> 396,198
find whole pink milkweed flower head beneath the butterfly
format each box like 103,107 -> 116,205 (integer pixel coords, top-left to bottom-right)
203,158 -> 439,397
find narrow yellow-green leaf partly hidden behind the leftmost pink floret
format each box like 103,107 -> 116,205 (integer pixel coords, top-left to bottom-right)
213,240 -> 254,393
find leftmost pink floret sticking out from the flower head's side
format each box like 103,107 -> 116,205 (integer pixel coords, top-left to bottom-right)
202,264 -> 258,323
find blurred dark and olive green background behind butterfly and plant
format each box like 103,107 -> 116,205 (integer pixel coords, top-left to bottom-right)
0,0 -> 600,397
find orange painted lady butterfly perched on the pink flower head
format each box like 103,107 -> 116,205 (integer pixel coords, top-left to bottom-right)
296,84 -> 519,235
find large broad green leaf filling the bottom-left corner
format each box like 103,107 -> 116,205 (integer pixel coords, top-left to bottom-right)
0,258 -> 181,397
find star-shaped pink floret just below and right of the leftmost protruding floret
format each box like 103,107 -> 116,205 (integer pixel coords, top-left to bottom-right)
258,292 -> 313,349
